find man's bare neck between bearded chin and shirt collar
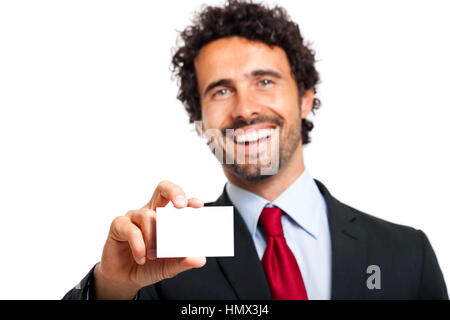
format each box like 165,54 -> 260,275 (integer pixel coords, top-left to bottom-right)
224,145 -> 305,202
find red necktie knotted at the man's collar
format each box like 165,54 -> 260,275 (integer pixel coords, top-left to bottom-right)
259,207 -> 308,300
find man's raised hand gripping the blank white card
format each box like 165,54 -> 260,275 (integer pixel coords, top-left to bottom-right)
94,181 -> 206,299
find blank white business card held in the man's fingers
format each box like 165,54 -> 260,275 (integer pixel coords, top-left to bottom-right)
156,207 -> 234,258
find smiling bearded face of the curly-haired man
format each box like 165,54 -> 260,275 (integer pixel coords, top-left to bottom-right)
195,37 -> 313,181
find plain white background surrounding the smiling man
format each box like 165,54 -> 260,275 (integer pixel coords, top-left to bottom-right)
0,0 -> 450,299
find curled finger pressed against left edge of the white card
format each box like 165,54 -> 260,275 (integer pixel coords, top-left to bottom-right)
127,208 -> 156,257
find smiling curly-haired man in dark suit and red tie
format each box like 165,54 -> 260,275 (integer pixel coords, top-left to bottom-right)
64,1 -> 448,299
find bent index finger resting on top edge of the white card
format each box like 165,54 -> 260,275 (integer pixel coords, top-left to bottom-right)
144,180 -> 187,210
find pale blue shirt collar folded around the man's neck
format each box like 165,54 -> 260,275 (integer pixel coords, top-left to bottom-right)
226,170 -> 326,238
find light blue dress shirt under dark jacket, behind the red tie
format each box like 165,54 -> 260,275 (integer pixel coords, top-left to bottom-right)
225,170 -> 331,300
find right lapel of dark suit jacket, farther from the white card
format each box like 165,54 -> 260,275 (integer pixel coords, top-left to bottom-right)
314,179 -> 367,300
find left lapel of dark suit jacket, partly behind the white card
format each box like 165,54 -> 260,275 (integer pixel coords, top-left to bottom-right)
205,189 -> 271,300
